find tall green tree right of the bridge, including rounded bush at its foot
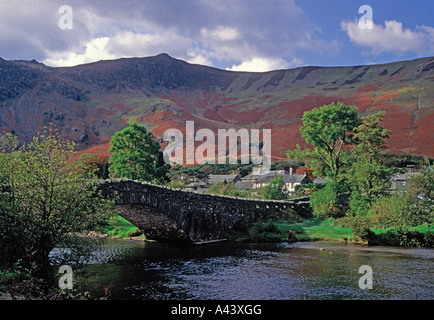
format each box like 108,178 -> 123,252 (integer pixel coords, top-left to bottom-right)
287,102 -> 360,217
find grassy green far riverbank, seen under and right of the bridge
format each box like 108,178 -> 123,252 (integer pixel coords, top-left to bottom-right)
99,216 -> 434,247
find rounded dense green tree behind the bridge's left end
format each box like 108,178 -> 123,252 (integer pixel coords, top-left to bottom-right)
109,122 -> 170,184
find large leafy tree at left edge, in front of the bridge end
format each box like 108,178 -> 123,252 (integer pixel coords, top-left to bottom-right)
0,129 -> 114,276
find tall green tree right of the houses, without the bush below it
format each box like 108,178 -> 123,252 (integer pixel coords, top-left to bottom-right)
287,102 -> 359,180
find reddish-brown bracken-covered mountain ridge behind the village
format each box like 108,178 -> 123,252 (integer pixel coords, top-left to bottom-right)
0,54 -> 434,158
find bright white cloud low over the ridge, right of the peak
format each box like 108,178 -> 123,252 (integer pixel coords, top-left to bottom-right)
226,58 -> 302,72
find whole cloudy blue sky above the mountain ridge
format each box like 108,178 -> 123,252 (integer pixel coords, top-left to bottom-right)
0,0 -> 434,72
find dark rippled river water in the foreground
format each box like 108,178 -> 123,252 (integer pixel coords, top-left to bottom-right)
56,239 -> 434,300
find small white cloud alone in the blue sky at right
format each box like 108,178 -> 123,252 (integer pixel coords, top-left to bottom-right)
341,20 -> 434,55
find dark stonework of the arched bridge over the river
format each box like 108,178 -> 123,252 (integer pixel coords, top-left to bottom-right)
100,179 -> 310,242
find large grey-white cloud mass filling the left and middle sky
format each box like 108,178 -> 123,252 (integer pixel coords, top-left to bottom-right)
0,0 -> 337,71
